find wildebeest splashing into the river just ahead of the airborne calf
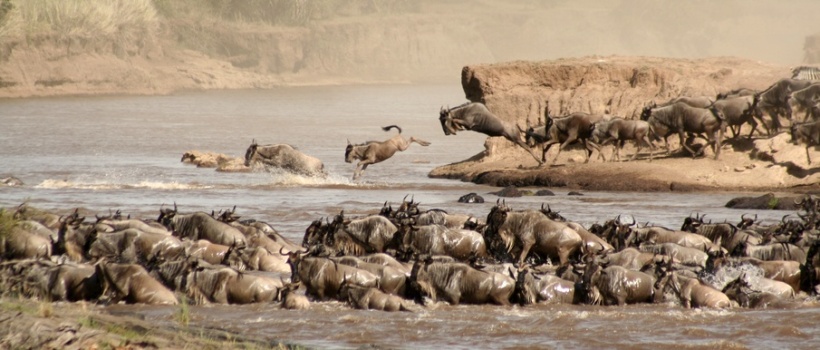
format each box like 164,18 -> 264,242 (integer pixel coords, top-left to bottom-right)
245,140 -> 327,176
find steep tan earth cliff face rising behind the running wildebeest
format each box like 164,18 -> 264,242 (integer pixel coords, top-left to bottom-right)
461,56 -> 790,125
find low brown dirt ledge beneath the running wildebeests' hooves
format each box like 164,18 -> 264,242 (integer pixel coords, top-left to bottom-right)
430,134 -> 820,193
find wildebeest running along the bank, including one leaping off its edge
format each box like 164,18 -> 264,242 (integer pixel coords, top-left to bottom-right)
439,67 -> 820,164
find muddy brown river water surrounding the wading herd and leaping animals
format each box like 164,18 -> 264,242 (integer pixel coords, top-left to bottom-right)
0,85 -> 820,348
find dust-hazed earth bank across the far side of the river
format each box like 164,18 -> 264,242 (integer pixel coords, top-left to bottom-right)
0,0 -> 820,97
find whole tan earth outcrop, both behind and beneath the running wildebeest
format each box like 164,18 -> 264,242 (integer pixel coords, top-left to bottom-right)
429,56 -> 820,191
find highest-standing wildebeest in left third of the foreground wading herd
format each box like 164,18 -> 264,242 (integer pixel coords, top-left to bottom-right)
157,204 -> 247,246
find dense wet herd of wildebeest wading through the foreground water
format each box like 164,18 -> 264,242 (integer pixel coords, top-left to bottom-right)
0,191 -> 820,311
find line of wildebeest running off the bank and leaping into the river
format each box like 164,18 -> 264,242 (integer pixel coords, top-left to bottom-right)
243,67 -> 820,180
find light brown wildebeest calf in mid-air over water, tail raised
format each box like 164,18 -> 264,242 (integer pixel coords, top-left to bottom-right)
345,125 -> 430,180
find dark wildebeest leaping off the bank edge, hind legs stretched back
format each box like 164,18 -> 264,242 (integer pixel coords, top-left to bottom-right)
438,102 -> 543,164
